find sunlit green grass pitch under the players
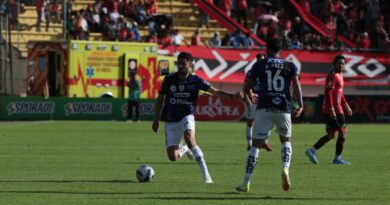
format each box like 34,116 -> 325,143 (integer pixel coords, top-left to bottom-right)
0,121 -> 390,205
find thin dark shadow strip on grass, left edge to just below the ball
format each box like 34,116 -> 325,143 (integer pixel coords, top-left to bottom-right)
0,179 -> 139,184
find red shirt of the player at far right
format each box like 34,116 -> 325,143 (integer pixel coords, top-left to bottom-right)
322,69 -> 344,114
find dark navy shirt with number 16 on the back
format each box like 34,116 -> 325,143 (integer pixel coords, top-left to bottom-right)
246,56 -> 298,113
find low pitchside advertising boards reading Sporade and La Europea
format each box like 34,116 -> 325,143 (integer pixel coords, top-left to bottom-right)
0,95 -> 390,123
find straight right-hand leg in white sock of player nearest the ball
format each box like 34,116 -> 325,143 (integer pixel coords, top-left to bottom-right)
181,115 -> 213,183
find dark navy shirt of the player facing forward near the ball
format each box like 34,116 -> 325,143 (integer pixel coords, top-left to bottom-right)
159,73 -> 211,122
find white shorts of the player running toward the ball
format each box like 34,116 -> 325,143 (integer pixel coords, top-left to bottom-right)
165,115 -> 195,148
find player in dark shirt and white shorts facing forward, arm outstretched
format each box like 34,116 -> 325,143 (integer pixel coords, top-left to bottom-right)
152,52 -> 242,183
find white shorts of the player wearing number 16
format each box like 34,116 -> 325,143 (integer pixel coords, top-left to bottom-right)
252,109 -> 292,139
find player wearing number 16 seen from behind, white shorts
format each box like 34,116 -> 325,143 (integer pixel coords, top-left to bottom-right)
236,38 -> 303,192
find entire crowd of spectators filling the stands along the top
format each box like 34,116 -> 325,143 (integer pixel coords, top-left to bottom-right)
1,0 -> 390,50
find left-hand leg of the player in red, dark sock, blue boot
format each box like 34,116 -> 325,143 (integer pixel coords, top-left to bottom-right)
305,114 -> 339,164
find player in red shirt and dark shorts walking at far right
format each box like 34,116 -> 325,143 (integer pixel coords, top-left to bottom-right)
305,55 -> 352,164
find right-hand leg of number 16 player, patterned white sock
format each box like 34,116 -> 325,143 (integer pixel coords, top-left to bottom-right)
274,113 -> 292,191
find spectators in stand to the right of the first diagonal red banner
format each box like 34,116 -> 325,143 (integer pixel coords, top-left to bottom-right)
209,0 -> 390,50
